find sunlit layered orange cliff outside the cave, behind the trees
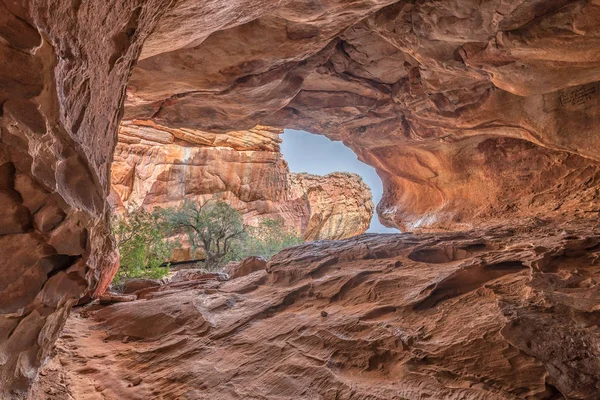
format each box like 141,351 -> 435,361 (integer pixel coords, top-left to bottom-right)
112,121 -> 374,244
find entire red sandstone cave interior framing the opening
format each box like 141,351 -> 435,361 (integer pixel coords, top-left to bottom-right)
0,0 -> 600,400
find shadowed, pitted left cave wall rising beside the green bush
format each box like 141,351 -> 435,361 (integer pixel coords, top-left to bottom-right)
0,1 -> 171,398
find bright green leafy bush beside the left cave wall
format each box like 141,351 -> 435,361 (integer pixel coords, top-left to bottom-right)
113,206 -> 176,286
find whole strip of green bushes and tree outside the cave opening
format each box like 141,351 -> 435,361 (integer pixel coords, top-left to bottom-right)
113,200 -> 303,286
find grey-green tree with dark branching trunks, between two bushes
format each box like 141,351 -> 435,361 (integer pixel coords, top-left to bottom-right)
169,200 -> 246,270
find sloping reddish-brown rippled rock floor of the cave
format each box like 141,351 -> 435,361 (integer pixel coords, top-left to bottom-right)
30,220 -> 600,400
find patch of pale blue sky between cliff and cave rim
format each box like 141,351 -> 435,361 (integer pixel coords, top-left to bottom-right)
281,129 -> 398,233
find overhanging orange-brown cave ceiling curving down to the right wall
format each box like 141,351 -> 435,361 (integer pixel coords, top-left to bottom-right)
125,0 -> 600,230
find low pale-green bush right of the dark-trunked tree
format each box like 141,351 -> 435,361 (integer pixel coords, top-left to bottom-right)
237,219 -> 304,260
